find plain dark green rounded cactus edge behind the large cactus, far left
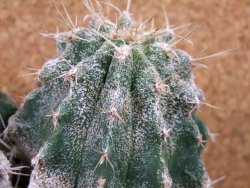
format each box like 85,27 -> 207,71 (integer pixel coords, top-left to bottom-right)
0,92 -> 17,132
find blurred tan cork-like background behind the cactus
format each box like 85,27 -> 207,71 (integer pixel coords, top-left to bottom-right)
0,0 -> 250,188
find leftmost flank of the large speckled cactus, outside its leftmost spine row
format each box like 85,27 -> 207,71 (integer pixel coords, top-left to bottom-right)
6,30 -> 104,158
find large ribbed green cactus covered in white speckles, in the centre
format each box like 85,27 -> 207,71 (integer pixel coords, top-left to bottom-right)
5,1 -> 213,188
